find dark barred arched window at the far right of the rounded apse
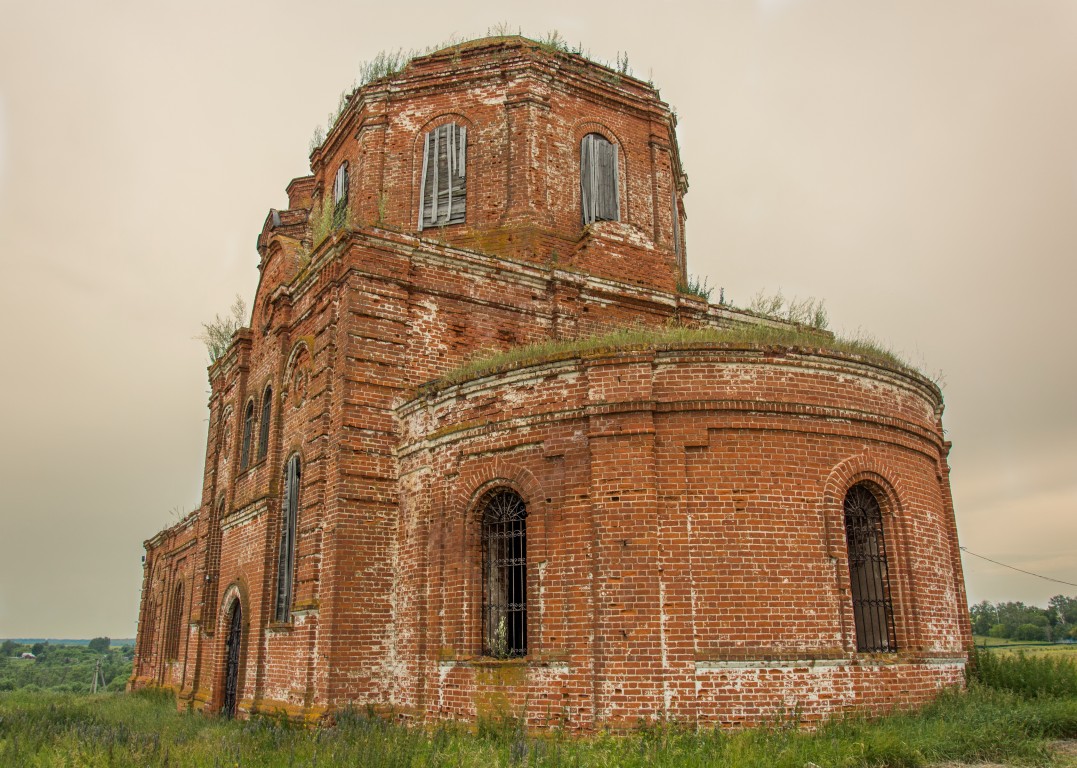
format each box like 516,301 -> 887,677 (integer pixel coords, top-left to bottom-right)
844,483 -> 897,653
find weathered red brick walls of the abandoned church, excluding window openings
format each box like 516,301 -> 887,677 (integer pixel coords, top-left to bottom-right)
132,39 -> 968,727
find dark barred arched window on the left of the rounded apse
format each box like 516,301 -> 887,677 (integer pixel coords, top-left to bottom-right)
481,488 -> 528,658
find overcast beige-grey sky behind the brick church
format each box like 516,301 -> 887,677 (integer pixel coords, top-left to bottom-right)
0,0 -> 1077,638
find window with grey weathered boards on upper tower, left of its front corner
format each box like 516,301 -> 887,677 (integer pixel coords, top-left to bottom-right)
419,123 -> 467,229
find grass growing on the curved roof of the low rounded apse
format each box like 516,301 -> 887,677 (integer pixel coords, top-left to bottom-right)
429,323 -> 910,389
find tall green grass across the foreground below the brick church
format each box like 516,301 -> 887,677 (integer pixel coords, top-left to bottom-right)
0,684 -> 1077,768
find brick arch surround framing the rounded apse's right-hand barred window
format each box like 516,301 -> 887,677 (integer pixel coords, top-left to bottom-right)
823,453 -> 920,651
